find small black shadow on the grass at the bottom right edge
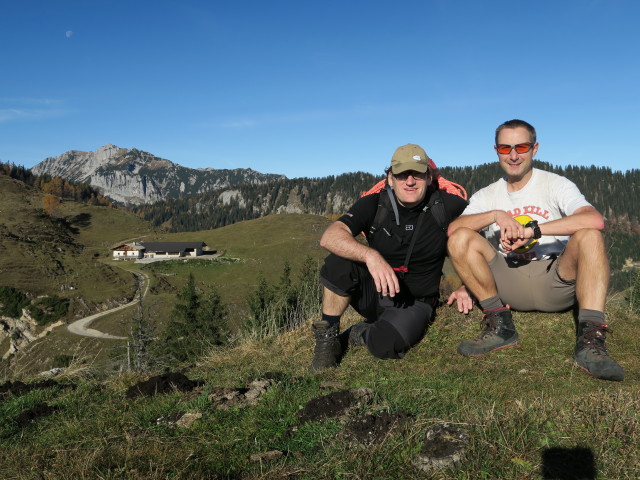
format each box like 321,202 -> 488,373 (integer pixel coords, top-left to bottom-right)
542,447 -> 596,480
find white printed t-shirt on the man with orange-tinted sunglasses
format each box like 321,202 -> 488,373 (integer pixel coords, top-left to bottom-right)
463,168 -> 591,260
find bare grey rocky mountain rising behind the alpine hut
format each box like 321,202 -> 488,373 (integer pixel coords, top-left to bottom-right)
31,145 -> 285,205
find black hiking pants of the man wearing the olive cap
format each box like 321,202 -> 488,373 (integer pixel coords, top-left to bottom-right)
320,254 -> 438,359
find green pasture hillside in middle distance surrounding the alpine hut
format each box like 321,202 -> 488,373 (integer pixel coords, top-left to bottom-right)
0,180 -> 330,376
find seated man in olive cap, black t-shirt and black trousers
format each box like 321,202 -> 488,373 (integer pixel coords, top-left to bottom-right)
311,144 -> 472,370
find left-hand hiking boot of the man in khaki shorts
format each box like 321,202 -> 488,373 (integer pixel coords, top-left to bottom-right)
458,307 -> 519,357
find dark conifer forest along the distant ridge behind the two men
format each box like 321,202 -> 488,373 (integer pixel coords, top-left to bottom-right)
0,160 -> 640,287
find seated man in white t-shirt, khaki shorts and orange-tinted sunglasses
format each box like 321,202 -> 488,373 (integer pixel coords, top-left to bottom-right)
448,120 -> 624,381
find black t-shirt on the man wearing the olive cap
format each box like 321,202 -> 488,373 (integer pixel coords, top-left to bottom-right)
338,190 -> 467,297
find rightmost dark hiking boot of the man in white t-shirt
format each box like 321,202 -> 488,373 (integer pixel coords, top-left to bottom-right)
573,322 -> 624,382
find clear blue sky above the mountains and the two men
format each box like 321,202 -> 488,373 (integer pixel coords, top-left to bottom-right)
0,0 -> 640,178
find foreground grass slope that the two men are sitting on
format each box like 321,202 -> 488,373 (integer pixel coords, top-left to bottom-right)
0,296 -> 640,480
